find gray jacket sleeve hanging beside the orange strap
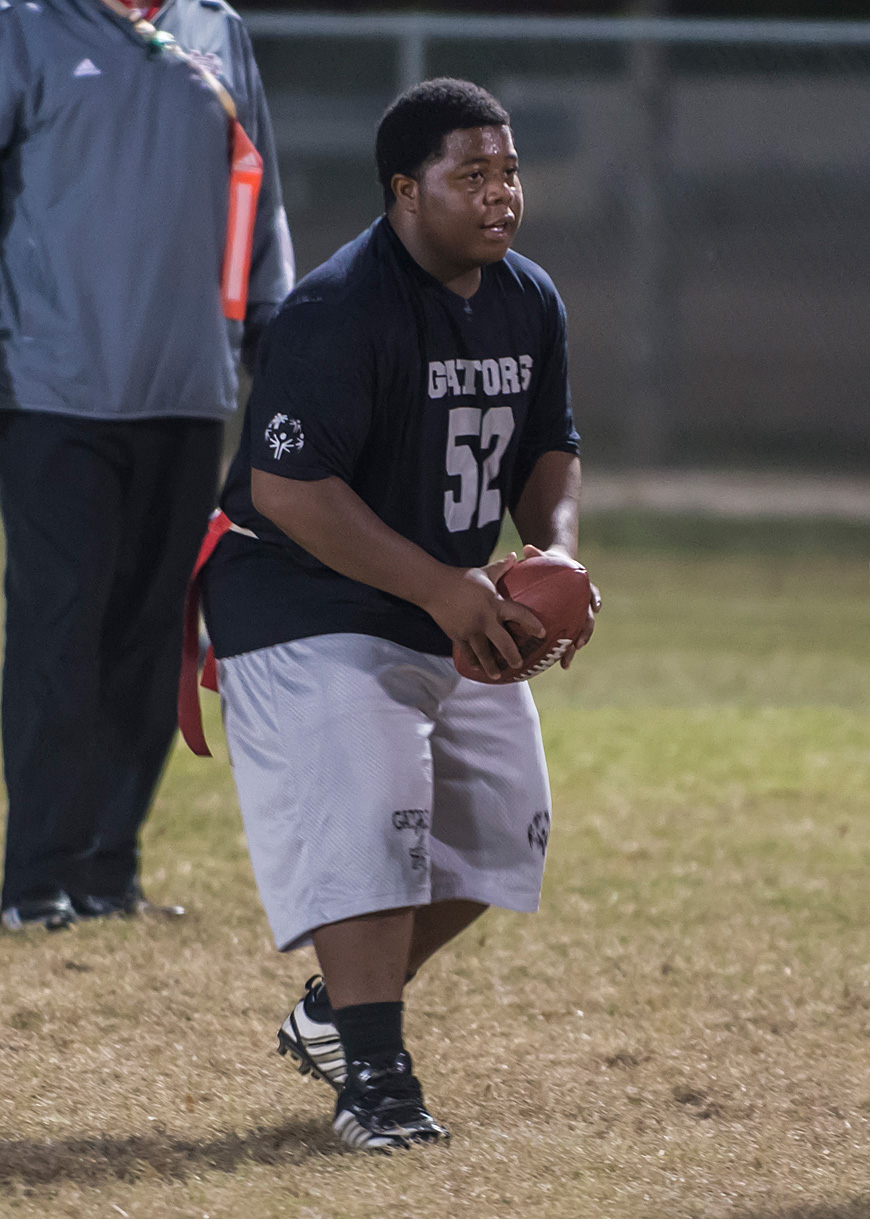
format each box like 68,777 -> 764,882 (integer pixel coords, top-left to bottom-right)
233,23 -> 296,372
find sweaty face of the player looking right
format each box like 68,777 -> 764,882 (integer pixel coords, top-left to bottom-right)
414,127 -> 523,279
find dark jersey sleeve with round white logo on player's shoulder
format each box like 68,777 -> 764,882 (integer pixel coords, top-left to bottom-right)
249,301 -> 375,484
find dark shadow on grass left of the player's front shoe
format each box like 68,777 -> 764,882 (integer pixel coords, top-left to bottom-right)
0,1120 -> 345,1192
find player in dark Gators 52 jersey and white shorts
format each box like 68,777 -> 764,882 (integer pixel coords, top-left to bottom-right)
203,79 -> 597,1147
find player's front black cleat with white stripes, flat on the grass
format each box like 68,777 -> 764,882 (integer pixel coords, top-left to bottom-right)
333,1051 -> 450,1150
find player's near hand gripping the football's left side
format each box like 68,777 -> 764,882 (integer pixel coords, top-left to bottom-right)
423,553 -> 545,678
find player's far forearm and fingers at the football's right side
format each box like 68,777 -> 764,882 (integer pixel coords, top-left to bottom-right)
511,451 -> 601,669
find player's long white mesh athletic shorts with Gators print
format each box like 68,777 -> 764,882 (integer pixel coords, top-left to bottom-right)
219,634 -> 550,950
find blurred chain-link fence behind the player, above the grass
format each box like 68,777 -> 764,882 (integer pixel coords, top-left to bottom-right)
245,12 -> 870,471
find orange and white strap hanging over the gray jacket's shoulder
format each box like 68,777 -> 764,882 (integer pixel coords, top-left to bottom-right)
102,0 -> 263,322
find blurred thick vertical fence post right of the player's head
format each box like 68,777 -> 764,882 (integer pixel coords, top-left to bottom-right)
624,0 -> 676,466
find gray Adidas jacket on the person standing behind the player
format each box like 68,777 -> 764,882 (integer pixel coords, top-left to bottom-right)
0,0 -> 292,419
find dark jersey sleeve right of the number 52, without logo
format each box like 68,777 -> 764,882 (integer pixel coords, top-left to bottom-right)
509,288 -> 580,511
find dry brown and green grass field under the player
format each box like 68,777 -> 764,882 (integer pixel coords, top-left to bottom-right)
0,516 -> 870,1219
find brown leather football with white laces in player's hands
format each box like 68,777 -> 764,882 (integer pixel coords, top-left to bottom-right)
453,555 -> 591,685
